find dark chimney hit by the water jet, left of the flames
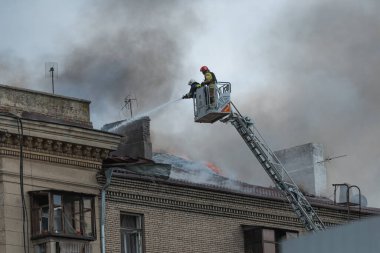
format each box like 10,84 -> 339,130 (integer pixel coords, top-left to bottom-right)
102,116 -> 152,159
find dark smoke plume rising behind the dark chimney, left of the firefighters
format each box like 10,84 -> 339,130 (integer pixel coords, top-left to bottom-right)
61,0 -> 198,123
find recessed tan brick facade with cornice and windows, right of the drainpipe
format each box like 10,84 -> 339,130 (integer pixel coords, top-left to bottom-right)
98,165 -> 379,253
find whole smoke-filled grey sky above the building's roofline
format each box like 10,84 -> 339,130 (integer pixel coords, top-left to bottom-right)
0,0 -> 380,207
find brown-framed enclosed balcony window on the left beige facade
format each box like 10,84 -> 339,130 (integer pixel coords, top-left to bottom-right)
30,191 -> 95,240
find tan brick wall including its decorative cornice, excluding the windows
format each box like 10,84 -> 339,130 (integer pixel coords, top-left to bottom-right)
101,177 -> 374,253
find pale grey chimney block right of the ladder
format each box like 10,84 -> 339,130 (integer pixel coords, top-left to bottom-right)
275,143 -> 327,197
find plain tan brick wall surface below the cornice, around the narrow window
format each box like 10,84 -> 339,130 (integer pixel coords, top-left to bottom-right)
106,203 -> 244,253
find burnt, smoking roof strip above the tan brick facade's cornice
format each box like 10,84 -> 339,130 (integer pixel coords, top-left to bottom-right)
103,153 -> 380,214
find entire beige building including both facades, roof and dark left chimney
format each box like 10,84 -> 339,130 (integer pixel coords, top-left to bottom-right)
0,85 -> 379,253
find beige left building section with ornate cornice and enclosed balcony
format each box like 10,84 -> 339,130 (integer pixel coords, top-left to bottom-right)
0,85 -> 120,253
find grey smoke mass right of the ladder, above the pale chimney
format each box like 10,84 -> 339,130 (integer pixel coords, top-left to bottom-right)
244,1 -> 380,205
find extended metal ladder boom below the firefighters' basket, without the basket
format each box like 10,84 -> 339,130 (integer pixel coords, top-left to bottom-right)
220,112 -> 325,231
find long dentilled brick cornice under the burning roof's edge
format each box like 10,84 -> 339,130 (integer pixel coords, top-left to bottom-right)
98,177 -> 368,227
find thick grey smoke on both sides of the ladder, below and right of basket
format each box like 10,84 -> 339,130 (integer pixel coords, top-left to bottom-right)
151,1 -> 380,206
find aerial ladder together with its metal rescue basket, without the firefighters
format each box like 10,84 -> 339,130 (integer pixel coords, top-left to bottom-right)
193,82 -> 325,232
